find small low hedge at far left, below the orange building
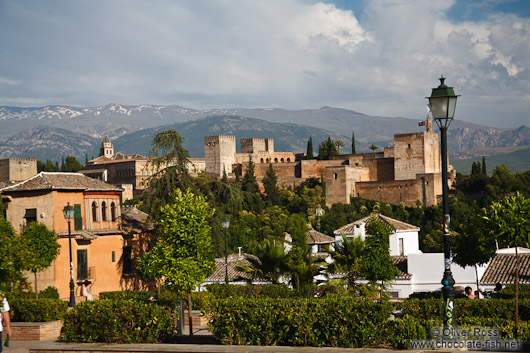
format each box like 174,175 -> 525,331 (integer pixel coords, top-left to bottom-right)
9,297 -> 68,322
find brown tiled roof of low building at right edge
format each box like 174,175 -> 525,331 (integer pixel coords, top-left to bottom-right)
480,254 -> 530,284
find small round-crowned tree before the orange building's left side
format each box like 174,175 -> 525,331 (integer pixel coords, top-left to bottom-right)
20,222 -> 60,299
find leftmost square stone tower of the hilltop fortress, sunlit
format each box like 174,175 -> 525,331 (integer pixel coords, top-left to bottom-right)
204,135 -> 236,177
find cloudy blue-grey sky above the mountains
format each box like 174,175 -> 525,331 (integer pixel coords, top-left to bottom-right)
0,0 -> 530,127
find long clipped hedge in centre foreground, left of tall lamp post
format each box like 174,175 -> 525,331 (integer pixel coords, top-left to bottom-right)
209,297 -> 391,347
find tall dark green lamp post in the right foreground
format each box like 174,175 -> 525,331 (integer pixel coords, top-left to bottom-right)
427,75 -> 458,328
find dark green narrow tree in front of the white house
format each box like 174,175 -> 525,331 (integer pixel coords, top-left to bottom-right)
361,217 -> 399,297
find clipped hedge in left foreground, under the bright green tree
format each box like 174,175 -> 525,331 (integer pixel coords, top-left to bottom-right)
59,299 -> 176,343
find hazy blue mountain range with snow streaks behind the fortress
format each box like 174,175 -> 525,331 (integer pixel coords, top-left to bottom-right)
0,104 -> 530,172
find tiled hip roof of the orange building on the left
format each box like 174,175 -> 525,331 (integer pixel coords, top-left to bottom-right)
0,172 -> 121,193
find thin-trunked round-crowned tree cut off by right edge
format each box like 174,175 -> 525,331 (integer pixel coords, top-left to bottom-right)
484,192 -> 530,337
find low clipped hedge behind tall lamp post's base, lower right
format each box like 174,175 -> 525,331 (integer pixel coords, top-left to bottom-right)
399,298 -> 530,322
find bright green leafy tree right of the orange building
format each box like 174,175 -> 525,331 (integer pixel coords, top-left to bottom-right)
138,189 -> 215,335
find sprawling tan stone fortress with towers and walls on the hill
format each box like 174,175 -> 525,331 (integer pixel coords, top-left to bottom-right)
204,118 -> 456,206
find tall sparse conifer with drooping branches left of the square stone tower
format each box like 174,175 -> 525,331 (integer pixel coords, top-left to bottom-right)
142,130 -> 193,220
